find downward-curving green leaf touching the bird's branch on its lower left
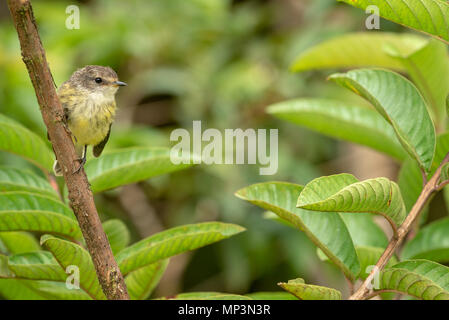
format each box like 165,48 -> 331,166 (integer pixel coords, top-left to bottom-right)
41,235 -> 106,300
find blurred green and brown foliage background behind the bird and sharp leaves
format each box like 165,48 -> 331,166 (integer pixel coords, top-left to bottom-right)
0,0 -> 406,296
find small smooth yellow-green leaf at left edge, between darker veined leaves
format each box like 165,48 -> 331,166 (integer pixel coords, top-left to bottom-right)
0,231 -> 41,254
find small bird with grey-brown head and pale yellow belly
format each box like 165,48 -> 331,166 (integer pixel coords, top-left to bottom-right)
53,66 -> 127,176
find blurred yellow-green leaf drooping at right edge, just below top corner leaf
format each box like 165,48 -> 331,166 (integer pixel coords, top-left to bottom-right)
389,39 -> 449,126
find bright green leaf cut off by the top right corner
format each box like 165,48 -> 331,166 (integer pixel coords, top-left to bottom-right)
338,0 -> 449,43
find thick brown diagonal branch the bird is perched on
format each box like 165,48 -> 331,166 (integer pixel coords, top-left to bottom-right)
8,0 -> 129,300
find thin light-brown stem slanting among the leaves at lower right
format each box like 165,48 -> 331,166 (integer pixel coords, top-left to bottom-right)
349,153 -> 449,300
